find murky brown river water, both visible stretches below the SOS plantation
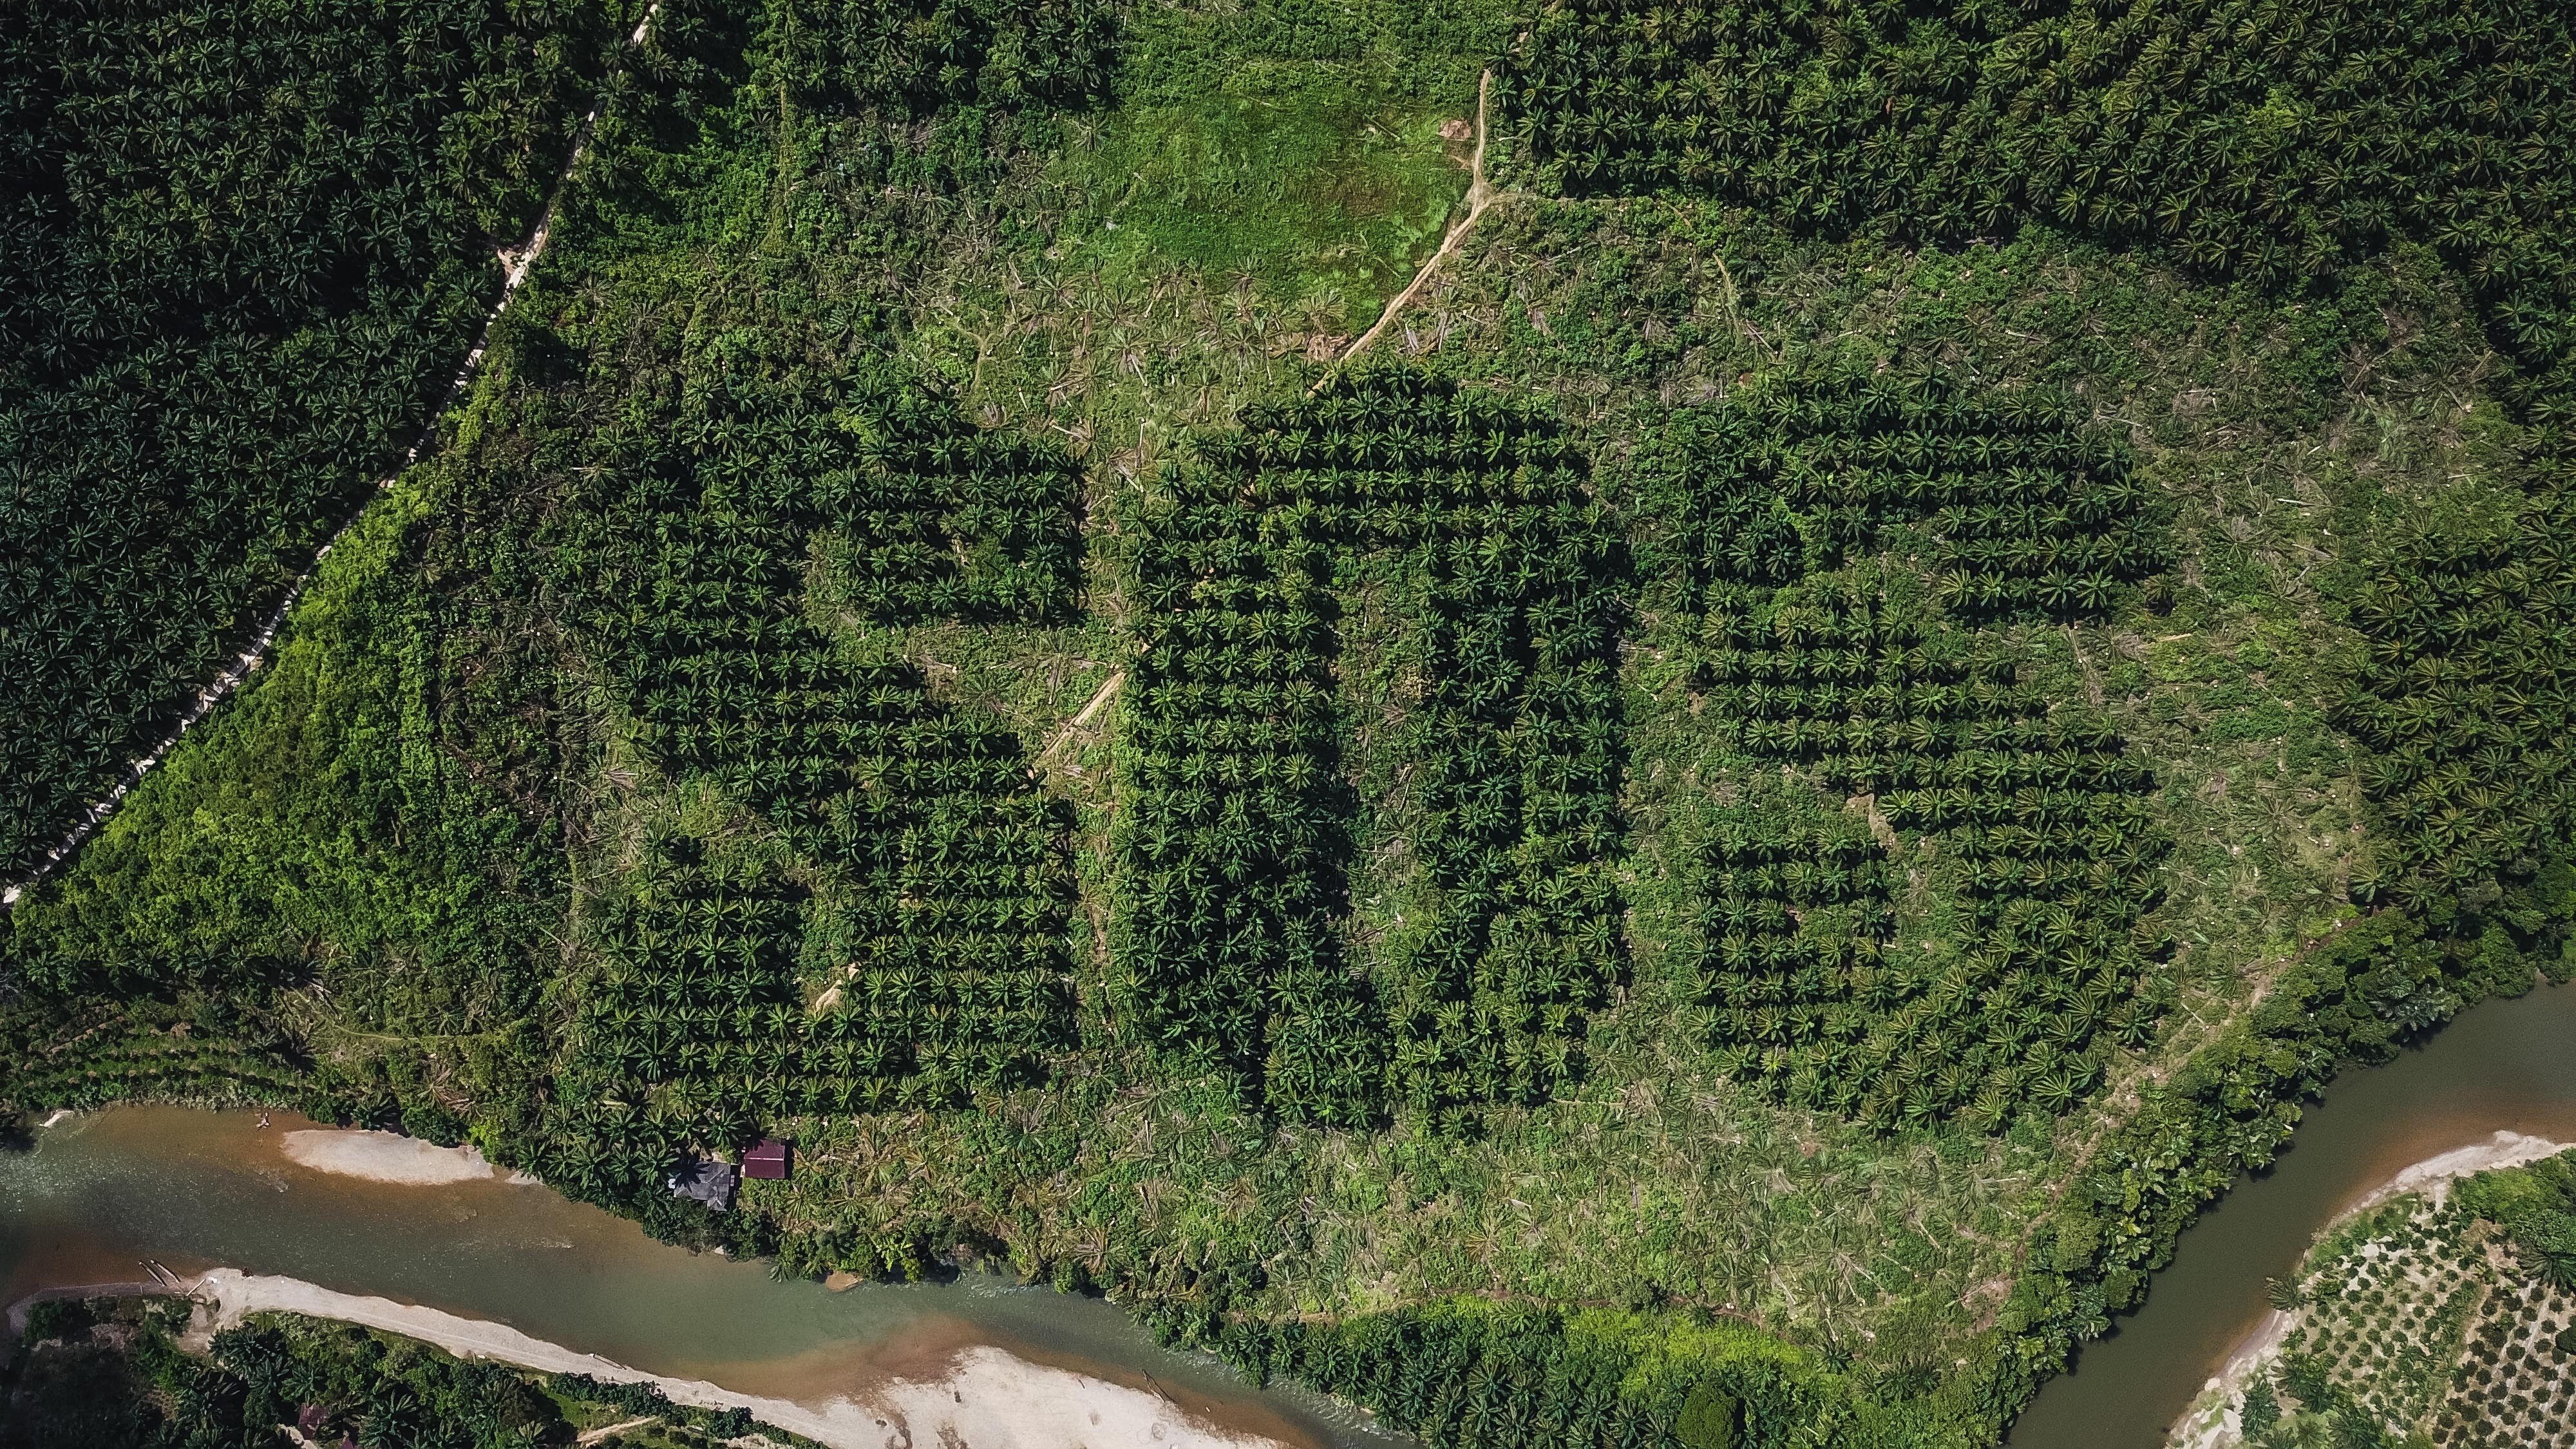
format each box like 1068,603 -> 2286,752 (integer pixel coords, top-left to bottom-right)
0,987 -> 2576,1449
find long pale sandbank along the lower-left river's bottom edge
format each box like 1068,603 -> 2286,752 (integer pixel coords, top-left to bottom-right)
193,1269 -> 1298,1449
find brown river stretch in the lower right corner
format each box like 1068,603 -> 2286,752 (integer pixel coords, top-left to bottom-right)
2009,969 -> 2576,1449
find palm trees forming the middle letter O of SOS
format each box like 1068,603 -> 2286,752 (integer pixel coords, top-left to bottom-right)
1113,372 -> 1623,1124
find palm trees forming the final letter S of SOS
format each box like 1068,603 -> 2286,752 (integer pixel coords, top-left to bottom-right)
1662,374 -> 2164,1130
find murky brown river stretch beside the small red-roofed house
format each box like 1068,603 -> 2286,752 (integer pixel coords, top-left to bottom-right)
0,1106 -> 1391,1449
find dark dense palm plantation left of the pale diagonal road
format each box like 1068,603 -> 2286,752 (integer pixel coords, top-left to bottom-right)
0,0 -> 608,879
